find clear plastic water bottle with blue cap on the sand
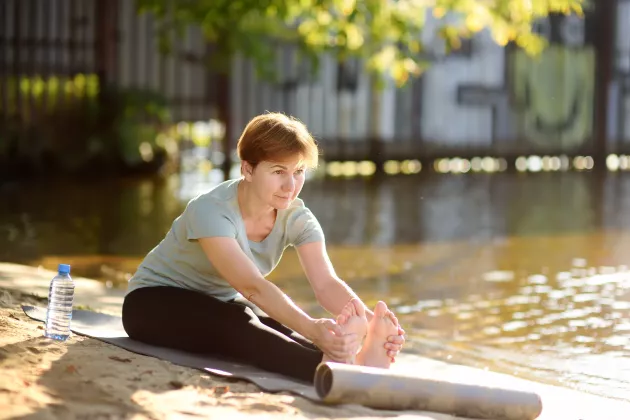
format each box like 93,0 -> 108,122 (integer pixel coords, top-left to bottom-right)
44,264 -> 74,341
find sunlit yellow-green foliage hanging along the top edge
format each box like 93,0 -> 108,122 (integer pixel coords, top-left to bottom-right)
137,0 -> 587,85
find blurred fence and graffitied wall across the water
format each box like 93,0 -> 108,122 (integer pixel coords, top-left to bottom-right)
0,0 -> 630,171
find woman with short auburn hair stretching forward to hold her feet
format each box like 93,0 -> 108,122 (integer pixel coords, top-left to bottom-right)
123,113 -> 404,382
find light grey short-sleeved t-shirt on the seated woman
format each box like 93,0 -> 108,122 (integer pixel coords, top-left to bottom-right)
127,179 -> 324,301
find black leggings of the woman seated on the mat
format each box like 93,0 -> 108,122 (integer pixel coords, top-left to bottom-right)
122,286 -> 323,383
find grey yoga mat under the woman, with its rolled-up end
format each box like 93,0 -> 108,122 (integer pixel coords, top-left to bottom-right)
22,306 -> 542,420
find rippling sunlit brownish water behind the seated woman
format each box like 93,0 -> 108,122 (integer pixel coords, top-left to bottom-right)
0,167 -> 630,400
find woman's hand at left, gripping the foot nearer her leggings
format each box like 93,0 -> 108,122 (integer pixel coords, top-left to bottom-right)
309,318 -> 361,363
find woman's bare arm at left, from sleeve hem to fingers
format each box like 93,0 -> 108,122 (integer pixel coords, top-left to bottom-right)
199,237 -> 356,360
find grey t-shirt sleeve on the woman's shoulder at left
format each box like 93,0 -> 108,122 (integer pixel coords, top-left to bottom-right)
184,200 -> 236,241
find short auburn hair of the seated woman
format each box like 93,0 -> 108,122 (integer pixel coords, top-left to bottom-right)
236,112 -> 319,169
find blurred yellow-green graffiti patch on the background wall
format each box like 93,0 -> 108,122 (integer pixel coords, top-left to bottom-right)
508,16 -> 595,149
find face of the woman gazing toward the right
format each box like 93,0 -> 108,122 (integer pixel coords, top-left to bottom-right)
243,157 -> 305,209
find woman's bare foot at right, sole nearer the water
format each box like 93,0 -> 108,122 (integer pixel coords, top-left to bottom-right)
357,301 -> 398,369
